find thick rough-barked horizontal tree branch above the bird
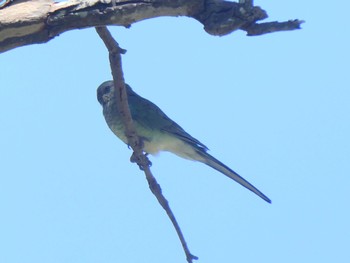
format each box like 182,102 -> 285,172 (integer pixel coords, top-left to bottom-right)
0,0 -> 303,53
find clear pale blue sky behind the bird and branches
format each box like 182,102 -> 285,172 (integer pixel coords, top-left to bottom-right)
0,0 -> 350,263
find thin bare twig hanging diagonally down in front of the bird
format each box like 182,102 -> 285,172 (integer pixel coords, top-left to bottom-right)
96,27 -> 198,263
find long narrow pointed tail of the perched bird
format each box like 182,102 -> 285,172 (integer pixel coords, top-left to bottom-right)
200,152 -> 271,203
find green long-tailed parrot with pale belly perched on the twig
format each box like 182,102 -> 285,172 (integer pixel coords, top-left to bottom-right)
97,81 -> 271,203
